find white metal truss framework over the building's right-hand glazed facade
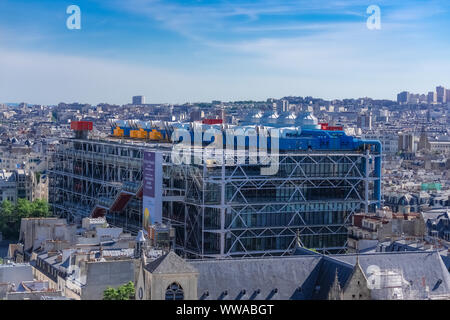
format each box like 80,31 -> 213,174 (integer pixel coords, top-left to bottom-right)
172,152 -> 381,258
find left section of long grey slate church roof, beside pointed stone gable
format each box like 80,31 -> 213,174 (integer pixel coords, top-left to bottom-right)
190,255 -> 322,300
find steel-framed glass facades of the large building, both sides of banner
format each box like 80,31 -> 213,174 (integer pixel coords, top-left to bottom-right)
49,139 -> 381,258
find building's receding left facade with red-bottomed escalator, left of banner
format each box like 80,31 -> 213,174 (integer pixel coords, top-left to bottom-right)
49,139 -> 182,233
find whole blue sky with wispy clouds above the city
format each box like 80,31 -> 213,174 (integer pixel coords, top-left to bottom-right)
0,0 -> 450,104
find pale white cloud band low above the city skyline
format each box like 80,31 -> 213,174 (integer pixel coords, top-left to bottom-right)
0,43 -> 450,104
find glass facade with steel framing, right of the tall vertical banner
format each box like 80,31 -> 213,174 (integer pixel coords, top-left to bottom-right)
178,150 -> 381,258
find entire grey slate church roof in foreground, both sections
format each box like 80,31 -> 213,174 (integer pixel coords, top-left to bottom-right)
188,251 -> 450,300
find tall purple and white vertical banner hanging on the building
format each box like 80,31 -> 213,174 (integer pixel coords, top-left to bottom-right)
142,152 -> 162,230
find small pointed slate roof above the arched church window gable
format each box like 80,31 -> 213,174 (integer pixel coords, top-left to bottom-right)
145,251 -> 197,274
